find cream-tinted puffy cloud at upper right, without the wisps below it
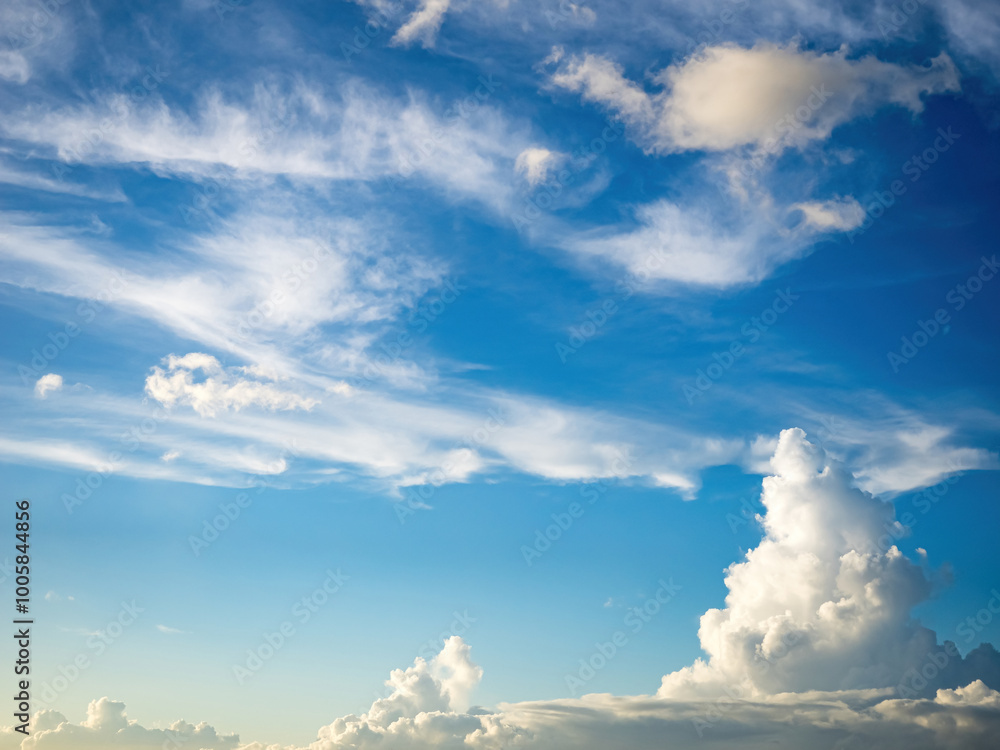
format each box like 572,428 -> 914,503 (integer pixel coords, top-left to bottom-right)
550,42 -> 959,153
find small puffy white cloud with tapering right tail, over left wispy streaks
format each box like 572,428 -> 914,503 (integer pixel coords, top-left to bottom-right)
146,352 -> 319,417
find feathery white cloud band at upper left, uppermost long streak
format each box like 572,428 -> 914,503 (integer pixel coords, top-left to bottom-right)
0,81 -> 528,209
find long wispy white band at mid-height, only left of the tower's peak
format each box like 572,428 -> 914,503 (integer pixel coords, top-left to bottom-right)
0,364 -> 743,497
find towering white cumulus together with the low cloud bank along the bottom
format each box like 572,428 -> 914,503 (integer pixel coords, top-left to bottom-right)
11,429 -> 1000,750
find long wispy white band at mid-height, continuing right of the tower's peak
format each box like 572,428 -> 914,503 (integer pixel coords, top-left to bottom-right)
0,355 -> 1000,504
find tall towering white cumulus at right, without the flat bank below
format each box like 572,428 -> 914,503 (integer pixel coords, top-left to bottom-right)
659,429 -> 1000,699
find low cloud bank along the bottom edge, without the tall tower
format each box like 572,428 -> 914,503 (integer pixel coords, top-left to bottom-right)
9,652 -> 1000,750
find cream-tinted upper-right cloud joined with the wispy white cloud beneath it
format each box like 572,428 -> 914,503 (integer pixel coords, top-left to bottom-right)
548,42 -> 958,290
